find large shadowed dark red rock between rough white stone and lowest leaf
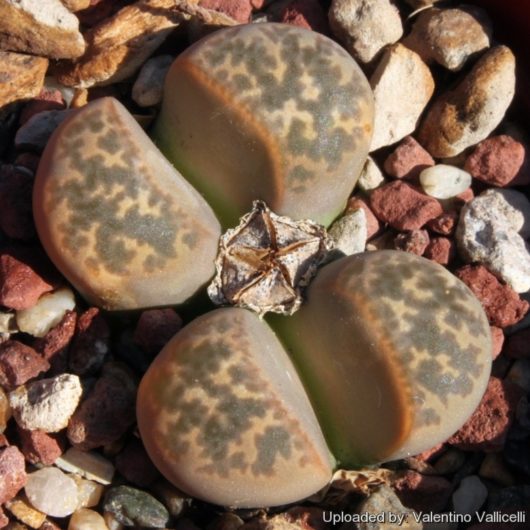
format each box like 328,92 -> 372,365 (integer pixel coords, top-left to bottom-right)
67,363 -> 137,451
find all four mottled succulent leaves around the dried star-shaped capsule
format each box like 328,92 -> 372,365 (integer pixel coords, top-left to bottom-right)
34,24 -> 491,506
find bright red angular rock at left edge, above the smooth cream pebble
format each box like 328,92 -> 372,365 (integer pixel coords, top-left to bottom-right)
0,249 -> 53,311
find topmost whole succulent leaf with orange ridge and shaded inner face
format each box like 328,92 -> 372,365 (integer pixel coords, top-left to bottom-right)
153,24 -> 373,227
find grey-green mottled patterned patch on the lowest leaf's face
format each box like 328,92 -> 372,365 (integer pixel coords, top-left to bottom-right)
148,314 -> 307,478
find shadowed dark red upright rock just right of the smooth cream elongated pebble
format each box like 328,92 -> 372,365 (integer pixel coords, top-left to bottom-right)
68,307 -> 110,375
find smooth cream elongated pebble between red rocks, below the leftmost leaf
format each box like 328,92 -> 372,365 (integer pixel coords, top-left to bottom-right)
17,288 -> 75,337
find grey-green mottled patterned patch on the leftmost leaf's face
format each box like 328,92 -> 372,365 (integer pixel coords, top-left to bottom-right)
54,106 -> 184,274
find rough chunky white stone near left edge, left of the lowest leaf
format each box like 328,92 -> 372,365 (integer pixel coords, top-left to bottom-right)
9,374 -> 82,432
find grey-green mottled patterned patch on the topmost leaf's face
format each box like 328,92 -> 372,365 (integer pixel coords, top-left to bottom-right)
199,25 -> 369,191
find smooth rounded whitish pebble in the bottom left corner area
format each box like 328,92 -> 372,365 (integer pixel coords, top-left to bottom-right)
24,467 -> 77,517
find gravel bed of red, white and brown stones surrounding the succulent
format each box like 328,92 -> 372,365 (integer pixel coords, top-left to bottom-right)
0,0 -> 530,530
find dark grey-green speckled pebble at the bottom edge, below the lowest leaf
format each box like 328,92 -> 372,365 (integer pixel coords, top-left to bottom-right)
103,486 -> 169,528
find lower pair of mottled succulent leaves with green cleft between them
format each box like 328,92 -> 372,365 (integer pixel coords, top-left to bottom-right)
137,251 -> 491,507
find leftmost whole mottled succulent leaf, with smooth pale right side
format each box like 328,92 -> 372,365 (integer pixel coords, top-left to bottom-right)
33,98 -> 220,310
